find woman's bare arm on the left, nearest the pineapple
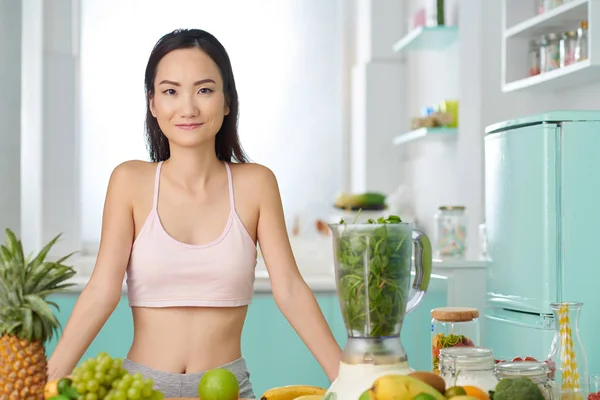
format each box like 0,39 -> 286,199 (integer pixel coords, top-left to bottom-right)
48,163 -> 135,380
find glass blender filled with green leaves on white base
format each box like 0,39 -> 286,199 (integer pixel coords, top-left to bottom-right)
327,216 -> 432,400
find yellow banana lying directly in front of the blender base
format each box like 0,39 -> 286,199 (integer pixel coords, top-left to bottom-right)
371,375 -> 445,400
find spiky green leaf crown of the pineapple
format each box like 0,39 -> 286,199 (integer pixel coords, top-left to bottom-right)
0,229 -> 76,343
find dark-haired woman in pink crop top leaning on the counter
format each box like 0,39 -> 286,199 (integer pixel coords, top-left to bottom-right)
48,29 -> 341,398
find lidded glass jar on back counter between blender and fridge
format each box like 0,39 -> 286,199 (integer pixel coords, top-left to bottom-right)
434,206 -> 467,259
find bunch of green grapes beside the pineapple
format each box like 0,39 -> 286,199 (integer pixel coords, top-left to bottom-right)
72,353 -> 164,400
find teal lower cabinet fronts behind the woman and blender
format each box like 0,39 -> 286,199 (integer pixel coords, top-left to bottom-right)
46,279 -> 447,396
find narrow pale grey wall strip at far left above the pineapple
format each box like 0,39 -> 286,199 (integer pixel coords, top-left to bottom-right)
0,0 -> 21,234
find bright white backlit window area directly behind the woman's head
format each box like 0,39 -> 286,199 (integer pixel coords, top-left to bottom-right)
80,0 -> 347,242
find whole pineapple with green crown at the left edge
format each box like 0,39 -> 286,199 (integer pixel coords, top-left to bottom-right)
0,229 -> 75,400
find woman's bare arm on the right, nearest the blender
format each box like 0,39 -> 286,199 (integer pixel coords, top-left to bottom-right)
257,168 -> 342,381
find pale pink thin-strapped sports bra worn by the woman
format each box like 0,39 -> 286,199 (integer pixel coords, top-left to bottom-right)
127,162 -> 257,307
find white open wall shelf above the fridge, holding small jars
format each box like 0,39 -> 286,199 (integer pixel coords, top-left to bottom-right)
501,0 -> 600,93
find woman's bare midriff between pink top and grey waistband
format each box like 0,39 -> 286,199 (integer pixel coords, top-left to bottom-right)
127,306 -> 248,374
